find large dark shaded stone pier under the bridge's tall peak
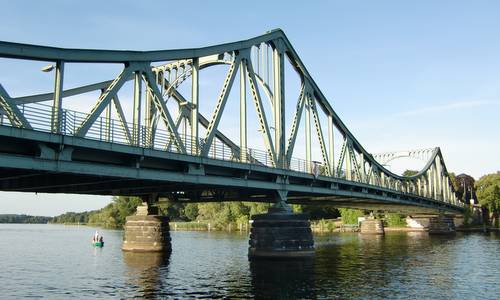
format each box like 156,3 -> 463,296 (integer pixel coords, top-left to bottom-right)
248,211 -> 314,259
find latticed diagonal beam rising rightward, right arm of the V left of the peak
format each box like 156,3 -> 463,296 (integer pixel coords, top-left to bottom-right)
201,56 -> 241,156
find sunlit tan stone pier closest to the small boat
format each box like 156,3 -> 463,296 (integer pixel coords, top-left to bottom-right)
122,198 -> 171,252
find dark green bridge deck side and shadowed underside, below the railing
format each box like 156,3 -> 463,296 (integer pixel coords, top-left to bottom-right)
0,127 -> 460,214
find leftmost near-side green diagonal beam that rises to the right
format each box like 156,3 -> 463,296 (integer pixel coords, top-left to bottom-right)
75,63 -> 137,137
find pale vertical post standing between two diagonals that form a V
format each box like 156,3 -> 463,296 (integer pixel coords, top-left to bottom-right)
190,57 -> 200,155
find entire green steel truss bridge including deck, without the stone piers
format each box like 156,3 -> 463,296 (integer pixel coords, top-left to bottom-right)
0,30 -> 464,214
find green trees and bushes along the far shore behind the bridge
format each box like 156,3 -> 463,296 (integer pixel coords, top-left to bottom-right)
0,170 -> 500,232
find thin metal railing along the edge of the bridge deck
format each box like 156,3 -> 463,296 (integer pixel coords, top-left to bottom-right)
0,103 -> 325,175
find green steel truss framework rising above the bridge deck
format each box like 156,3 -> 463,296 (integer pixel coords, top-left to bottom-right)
0,30 -> 456,210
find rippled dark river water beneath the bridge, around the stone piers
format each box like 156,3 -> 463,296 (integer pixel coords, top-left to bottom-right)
0,224 -> 500,299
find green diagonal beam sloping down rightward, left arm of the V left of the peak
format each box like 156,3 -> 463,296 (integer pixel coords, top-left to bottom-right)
143,66 -> 186,154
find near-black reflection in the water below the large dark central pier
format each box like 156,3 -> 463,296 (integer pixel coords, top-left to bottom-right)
250,259 -> 315,299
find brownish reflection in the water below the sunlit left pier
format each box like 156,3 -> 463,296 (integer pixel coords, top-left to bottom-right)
123,252 -> 170,298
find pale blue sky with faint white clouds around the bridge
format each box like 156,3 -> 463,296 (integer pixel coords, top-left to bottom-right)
0,0 -> 500,216
